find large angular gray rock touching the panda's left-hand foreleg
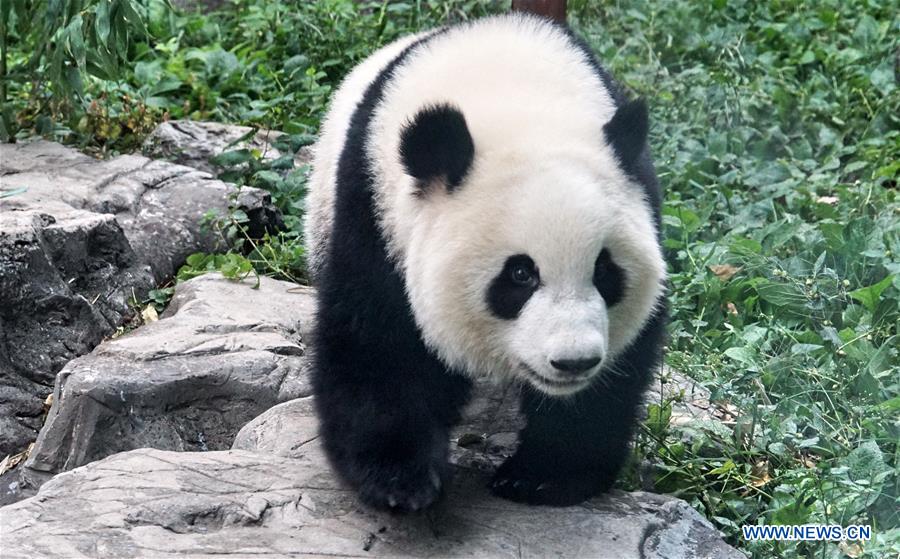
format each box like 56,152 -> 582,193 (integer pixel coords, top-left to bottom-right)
22,274 -> 313,485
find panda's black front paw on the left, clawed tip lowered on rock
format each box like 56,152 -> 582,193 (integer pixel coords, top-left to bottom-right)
359,464 -> 446,512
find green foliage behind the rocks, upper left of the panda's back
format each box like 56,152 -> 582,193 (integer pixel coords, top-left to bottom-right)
3,0 -> 505,148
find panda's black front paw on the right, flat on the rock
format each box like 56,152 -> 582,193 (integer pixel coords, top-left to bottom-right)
490,456 -> 615,507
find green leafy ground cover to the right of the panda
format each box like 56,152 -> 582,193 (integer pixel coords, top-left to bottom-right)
570,0 -> 900,557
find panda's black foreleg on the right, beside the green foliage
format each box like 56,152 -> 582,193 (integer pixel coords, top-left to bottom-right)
491,310 -> 664,506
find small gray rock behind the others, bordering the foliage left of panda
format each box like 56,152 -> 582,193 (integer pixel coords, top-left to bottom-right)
143,120 -> 312,174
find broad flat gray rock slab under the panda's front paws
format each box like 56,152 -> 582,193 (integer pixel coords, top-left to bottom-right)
0,439 -> 742,559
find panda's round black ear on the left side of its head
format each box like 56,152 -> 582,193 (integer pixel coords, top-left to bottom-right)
400,105 -> 475,192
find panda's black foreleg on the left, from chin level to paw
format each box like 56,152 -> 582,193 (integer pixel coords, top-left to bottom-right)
313,337 -> 469,512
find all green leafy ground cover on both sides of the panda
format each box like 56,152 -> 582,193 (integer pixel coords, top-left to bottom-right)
3,0 -> 900,558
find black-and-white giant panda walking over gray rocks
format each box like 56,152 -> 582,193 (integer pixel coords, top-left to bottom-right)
305,15 -> 665,512
